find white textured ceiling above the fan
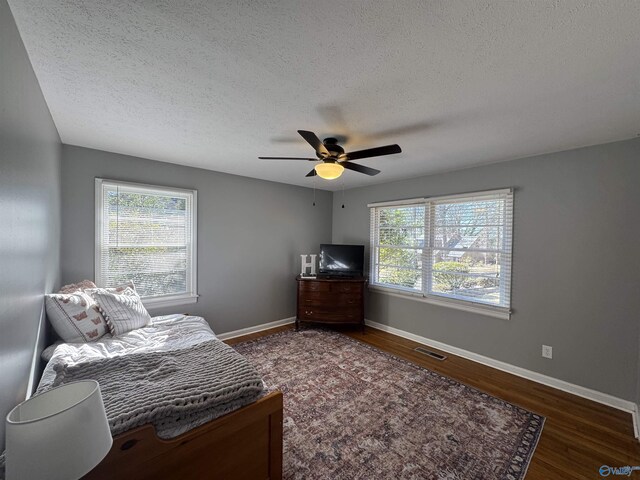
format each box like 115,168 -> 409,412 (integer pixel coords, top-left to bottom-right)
9,0 -> 640,190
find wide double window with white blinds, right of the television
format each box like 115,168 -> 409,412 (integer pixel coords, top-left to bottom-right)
369,190 -> 513,317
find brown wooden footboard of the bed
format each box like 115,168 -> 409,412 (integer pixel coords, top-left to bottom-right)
84,391 -> 282,480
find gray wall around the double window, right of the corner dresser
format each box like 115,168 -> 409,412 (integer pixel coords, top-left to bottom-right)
333,139 -> 640,401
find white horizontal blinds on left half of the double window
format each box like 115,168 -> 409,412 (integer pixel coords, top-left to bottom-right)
371,204 -> 425,292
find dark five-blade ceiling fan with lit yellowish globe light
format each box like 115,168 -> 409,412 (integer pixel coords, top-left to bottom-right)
258,130 -> 402,180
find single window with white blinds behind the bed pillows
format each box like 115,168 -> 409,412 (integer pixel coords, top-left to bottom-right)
95,179 -> 197,306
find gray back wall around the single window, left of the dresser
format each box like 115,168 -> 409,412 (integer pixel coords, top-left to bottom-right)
61,145 -> 332,333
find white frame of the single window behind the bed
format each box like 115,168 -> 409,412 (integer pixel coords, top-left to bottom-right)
94,178 -> 199,308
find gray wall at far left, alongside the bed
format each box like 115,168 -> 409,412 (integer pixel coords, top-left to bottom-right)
0,0 -> 61,450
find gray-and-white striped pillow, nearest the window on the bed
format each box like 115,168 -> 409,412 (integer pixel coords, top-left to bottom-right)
91,288 -> 151,336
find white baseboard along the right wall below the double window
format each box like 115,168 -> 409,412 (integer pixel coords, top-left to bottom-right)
365,320 -> 640,438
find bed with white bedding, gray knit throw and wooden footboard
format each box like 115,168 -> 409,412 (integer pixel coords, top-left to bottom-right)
38,315 -> 282,479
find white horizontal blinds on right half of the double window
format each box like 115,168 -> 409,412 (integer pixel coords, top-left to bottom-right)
426,191 -> 513,307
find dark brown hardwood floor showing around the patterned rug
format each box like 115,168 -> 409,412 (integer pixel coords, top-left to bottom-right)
227,326 -> 640,480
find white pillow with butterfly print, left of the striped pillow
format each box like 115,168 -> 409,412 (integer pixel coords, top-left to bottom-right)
45,291 -> 109,343
